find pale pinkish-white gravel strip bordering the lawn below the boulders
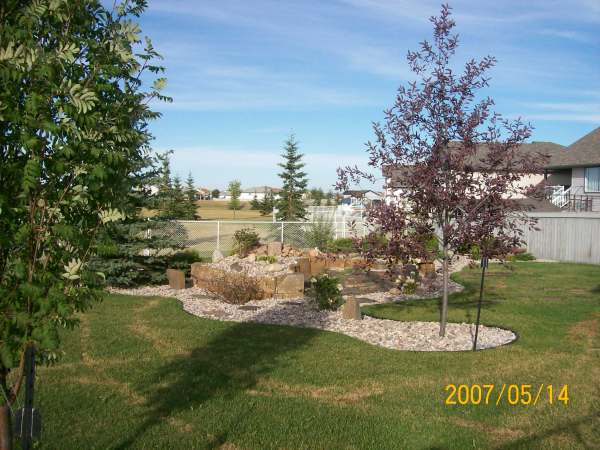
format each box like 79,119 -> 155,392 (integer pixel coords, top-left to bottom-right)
109,286 -> 516,351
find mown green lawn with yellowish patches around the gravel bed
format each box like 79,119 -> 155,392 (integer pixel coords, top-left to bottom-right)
36,263 -> 600,450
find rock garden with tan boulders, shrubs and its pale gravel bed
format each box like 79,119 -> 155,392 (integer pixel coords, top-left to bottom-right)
113,230 -> 516,351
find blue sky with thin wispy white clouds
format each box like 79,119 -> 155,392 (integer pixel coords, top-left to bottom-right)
141,0 -> 600,189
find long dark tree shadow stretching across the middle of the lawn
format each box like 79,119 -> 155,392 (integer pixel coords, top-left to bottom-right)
115,303 -> 319,449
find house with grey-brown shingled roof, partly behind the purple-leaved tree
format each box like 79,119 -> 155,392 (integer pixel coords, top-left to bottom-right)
383,128 -> 600,212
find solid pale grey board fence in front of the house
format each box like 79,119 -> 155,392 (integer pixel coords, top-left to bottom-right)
525,212 -> 600,264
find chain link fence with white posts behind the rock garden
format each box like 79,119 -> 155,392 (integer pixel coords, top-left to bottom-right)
164,218 -> 368,256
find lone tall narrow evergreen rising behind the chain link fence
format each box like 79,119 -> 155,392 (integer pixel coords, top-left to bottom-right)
276,135 -> 308,220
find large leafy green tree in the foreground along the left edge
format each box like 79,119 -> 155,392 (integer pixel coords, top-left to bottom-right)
0,0 -> 167,444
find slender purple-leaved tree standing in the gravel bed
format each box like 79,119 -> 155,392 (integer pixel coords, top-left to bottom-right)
338,5 -> 542,336
